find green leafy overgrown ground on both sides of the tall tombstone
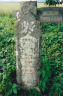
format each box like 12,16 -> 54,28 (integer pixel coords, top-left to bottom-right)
0,4 -> 63,96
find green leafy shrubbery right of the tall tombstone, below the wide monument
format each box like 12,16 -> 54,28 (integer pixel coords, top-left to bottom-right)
39,23 -> 63,96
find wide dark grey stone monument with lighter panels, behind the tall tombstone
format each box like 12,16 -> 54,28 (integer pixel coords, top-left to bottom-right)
37,7 -> 63,24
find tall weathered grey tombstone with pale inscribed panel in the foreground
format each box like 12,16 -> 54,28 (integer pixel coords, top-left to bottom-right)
15,1 -> 42,90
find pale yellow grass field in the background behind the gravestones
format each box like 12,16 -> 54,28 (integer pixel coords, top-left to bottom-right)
0,3 -> 63,14
